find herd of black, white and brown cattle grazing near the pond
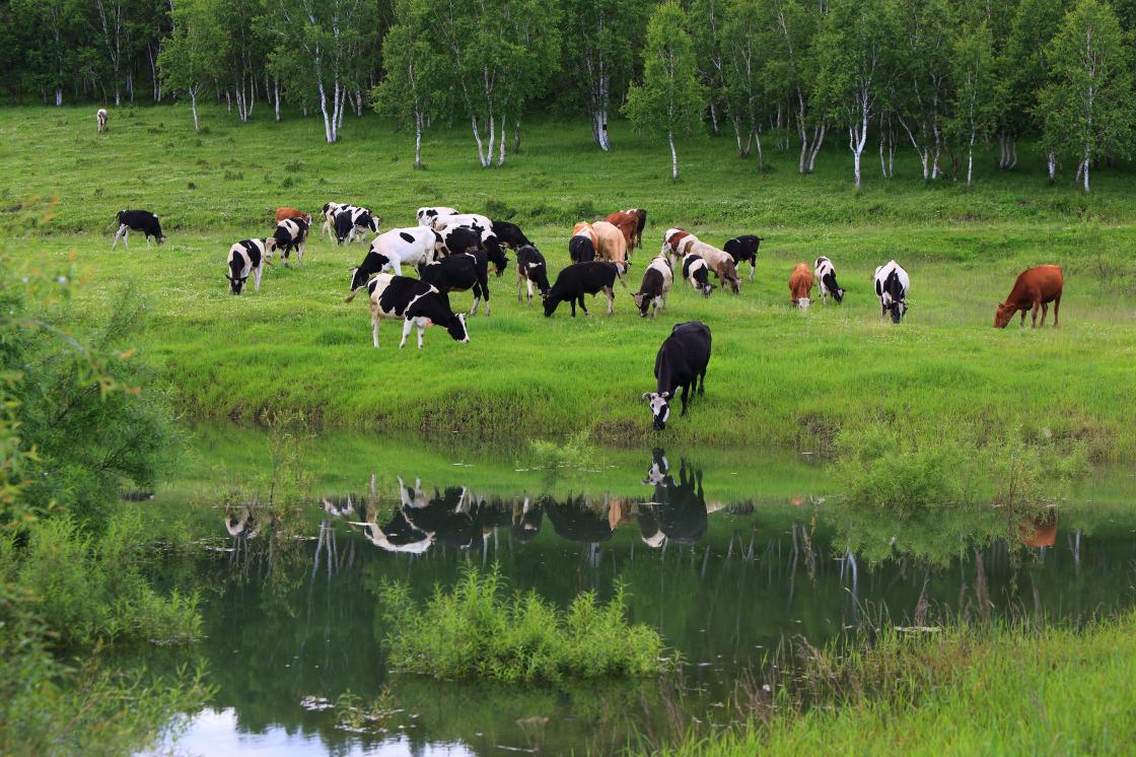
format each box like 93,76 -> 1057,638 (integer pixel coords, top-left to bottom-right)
111,202 -> 1064,430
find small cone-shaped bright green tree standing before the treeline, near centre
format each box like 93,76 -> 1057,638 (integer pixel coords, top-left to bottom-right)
624,0 -> 705,181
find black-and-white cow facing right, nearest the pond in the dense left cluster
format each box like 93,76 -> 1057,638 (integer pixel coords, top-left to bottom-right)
367,274 -> 469,349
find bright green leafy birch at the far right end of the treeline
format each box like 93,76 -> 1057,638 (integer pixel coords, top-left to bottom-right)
1038,0 -> 1134,192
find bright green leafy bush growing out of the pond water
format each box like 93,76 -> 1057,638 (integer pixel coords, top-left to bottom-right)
382,568 -> 663,682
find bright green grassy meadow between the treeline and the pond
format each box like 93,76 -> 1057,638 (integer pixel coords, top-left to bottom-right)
0,107 -> 1136,450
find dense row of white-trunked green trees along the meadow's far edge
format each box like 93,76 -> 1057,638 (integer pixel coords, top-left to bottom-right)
0,0 -> 1136,191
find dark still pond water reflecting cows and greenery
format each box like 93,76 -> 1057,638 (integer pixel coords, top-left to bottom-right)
145,445 -> 1136,755
